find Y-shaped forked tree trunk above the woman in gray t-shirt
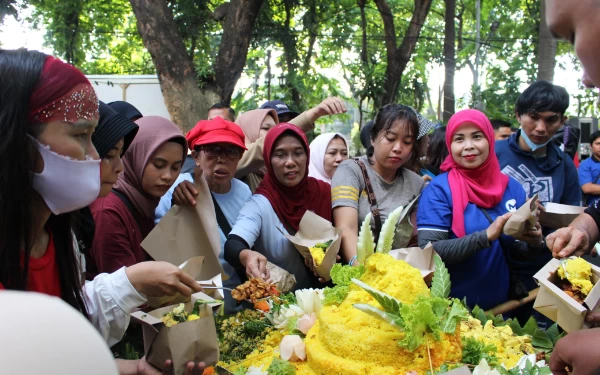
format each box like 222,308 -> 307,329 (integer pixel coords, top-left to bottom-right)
375,0 -> 432,107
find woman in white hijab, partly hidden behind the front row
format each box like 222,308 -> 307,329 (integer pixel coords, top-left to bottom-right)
308,133 -> 348,185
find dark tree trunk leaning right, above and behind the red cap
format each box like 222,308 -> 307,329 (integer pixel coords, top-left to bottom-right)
214,0 -> 263,104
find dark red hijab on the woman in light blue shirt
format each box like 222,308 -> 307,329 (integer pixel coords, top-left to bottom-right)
256,123 -> 331,231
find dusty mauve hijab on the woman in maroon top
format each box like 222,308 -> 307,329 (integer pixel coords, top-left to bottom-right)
115,116 -> 187,220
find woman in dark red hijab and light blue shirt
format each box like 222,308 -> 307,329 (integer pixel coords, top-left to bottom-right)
225,124 -> 331,289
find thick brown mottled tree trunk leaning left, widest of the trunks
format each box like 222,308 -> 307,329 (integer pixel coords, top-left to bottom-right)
130,0 -> 218,132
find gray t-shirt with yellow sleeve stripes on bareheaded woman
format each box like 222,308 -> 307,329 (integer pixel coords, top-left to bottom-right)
331,156 -> 425,249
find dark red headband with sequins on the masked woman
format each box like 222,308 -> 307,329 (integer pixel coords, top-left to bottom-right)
28,56 -> 100,124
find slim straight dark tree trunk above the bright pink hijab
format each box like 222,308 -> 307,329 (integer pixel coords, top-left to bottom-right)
443,0 -> 456,123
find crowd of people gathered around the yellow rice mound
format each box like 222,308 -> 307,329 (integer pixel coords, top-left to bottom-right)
0,0 -> 600,374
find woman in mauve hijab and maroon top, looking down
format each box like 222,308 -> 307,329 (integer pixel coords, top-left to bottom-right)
88,116 -> 187,273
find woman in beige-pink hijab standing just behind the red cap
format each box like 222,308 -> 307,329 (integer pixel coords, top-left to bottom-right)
235,109 -> 279,192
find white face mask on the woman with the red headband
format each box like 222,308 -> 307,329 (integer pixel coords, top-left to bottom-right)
31,138 -> 101,215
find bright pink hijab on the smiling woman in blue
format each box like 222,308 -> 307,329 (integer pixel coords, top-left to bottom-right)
440,109 -> 508,238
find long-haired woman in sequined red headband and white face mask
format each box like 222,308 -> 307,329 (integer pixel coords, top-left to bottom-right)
0,49 -> 204,374
